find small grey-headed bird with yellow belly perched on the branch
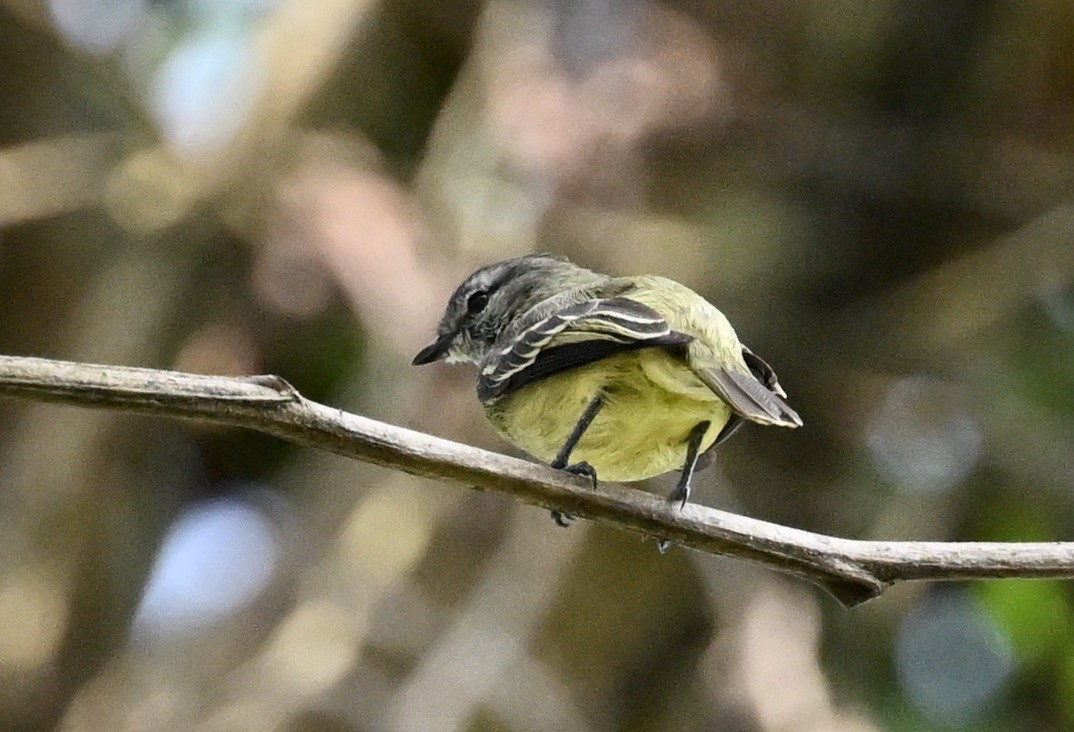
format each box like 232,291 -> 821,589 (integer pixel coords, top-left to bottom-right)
413,254 -> 802,525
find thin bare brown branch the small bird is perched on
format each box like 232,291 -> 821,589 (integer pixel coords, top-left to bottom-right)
0,356 -> 1074,606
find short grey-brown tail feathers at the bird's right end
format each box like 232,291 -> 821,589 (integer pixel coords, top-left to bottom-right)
690,347 -> 802,425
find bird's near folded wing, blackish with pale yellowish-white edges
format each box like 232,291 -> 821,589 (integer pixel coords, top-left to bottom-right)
478,297 -> 693,402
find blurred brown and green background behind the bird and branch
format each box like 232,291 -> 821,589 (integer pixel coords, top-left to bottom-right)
0,0 -> 1074,732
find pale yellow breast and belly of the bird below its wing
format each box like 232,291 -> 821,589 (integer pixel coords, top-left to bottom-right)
487,348 -> 730,482
